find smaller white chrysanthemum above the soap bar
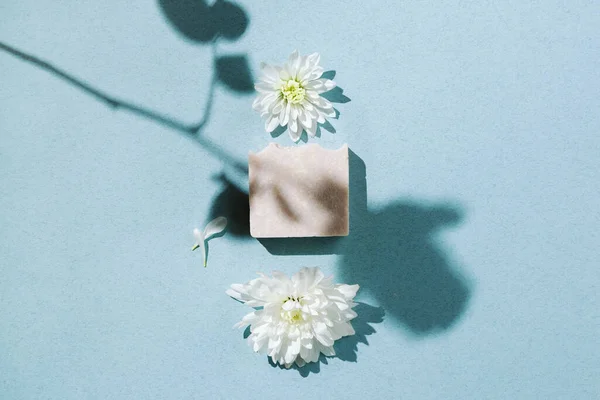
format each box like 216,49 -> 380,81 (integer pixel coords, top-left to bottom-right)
252,50 -> 335,142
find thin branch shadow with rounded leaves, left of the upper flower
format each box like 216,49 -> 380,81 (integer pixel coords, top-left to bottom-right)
0,0 -> 254,172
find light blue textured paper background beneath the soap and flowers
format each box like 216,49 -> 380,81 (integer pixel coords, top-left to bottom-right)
0,0 -> 600,399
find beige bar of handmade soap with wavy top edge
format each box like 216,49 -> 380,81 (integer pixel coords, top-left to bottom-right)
248,143 -> 349,238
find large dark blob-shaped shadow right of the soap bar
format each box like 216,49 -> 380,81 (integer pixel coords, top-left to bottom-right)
339,202 -> 471,335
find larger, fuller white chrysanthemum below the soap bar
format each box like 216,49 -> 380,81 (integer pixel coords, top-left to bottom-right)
227,268 -> 358,368
